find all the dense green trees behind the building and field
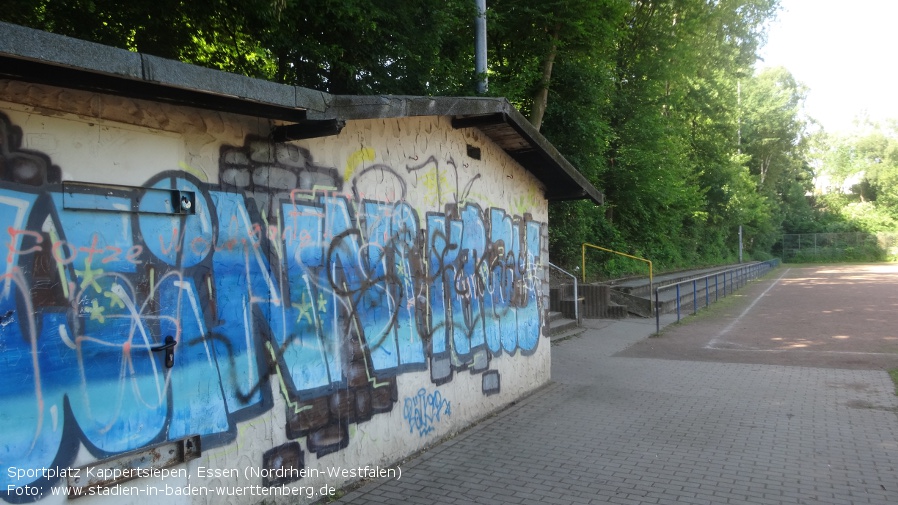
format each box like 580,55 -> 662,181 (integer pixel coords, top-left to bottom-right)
7,0 -> 880,275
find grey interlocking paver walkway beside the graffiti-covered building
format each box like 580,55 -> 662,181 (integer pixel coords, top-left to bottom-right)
330,310 -> 898,505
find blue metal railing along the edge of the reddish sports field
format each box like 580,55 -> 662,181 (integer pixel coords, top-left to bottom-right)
655,259 -> 780,333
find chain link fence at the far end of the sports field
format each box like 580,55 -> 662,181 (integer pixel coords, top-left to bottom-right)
783,232 -> 898,263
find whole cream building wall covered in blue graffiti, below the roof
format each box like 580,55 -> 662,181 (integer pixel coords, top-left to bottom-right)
0,81 -> 550,504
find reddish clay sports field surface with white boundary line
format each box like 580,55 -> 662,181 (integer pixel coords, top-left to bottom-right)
619,263 -> 898,370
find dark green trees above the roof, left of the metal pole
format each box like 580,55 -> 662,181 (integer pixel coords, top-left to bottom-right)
0,0 -> 475,95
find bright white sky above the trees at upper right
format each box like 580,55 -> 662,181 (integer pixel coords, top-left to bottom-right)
759,0 -> 898,132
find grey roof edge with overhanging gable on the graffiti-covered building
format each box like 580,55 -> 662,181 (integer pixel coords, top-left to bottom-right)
0,22 -> 603,204
